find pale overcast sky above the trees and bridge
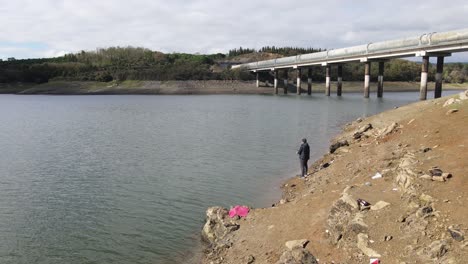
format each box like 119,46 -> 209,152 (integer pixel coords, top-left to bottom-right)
0,0 -> 468,61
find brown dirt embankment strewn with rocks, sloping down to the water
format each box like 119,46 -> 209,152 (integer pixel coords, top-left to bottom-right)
202,91 -> 468,264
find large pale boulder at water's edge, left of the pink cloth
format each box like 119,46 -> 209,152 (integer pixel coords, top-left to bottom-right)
202,206 -> 239,245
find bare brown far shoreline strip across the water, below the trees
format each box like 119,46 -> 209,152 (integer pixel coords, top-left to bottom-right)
0,80 -> 468,95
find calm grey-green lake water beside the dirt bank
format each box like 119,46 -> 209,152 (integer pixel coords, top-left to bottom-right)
0,93 -> 454,264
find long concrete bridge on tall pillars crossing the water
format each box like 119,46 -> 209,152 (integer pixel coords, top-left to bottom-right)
233,29 -> 468,100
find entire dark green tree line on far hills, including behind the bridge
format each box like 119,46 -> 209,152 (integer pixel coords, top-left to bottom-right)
0,47 -> 468,83
